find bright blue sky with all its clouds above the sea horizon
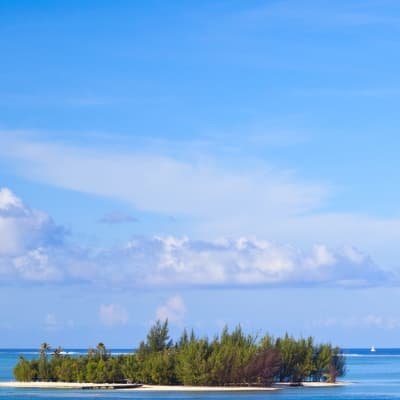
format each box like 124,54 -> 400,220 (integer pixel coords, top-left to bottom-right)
0,0 -> 400,347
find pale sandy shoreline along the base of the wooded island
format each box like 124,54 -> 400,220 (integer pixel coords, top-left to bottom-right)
0,381 -> 350,392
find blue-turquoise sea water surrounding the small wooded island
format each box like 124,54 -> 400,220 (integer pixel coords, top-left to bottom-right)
0,349 -> 400,400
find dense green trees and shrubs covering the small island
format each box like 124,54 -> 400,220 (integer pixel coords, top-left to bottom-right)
14,321 -> 345,386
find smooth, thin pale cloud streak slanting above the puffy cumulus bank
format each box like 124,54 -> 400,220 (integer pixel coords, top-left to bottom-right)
0,140 -> 327,223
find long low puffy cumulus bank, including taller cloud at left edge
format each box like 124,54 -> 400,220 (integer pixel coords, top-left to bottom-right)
0,188 -> 392,288
